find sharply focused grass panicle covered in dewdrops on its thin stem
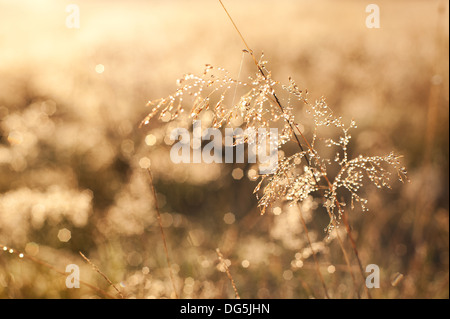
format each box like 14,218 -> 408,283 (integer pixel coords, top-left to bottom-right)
141,0 -> 407,297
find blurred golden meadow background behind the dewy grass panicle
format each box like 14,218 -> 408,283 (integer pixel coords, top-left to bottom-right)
0,0 -> 449,298
